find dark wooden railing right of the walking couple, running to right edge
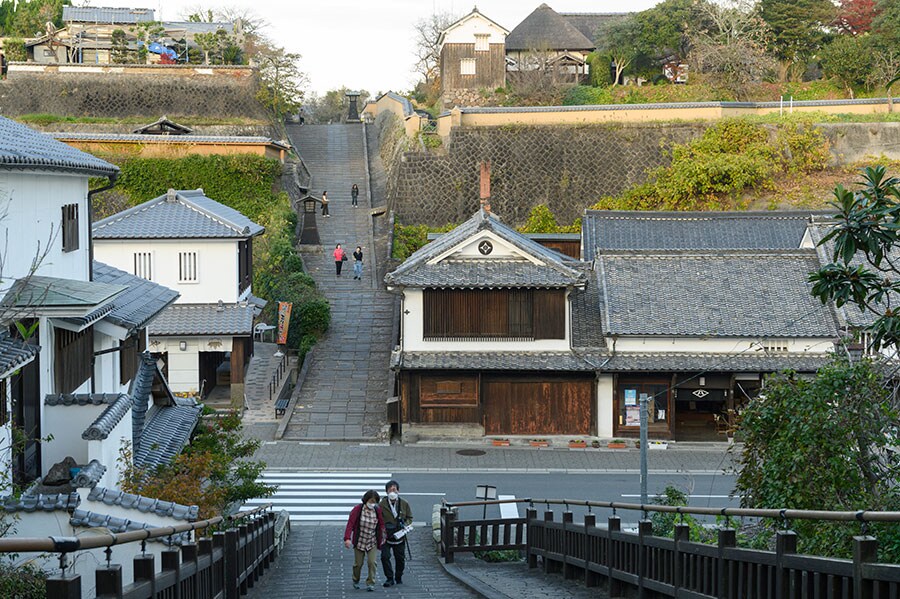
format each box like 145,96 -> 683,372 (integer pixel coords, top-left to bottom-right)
440,499 -> 900,599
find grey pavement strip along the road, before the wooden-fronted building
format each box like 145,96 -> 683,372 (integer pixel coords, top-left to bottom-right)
246,438 -> 732,473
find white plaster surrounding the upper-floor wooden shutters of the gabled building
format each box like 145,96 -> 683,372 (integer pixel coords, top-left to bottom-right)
402,289 -> 571,352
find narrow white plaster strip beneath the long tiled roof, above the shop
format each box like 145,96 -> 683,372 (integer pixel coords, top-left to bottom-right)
606,337 -> 834,355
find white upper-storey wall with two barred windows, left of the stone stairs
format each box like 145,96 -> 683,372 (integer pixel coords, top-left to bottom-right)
94,239 -> 238,304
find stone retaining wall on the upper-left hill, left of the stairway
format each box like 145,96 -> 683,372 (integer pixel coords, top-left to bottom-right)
0,71 -> 266,120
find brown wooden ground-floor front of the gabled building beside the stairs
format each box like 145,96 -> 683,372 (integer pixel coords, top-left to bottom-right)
400,372 -> 597,435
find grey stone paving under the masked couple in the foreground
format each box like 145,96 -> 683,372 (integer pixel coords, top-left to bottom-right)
239,524 -> 478,599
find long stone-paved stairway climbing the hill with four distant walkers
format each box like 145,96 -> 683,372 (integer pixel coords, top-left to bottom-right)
282,124 -> 393,441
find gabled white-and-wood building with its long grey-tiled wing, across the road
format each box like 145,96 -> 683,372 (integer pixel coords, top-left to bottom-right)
386,211 -> 839,440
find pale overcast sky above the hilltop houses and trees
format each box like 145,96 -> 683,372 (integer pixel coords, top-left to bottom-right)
93,0 -> 657,94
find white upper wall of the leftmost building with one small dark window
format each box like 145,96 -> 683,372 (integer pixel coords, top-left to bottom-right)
0,171 -> 90,288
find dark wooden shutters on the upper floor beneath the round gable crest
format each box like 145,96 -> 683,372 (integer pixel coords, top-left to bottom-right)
424,288 -> 566,339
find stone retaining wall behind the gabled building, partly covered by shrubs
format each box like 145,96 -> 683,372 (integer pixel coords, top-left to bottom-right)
385,123 -> 900,226
